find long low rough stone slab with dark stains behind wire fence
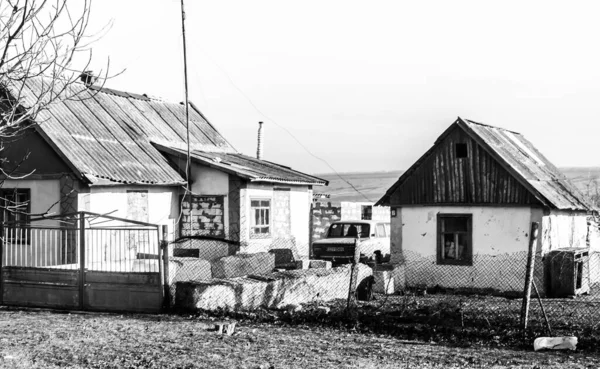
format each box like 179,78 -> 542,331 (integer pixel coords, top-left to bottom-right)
175,264 -> 373,311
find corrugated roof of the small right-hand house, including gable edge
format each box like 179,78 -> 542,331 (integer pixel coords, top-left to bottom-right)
376,117 -> 597,211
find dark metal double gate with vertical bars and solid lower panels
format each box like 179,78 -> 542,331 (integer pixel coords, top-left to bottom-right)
0,212 -> 164,312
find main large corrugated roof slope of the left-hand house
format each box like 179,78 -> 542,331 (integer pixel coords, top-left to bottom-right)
8,77 -> 236,185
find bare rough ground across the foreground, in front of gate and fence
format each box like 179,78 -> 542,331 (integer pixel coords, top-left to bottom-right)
0,309 -> 600,369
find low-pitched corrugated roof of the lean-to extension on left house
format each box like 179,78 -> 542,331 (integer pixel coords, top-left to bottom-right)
156,143 -> 328,186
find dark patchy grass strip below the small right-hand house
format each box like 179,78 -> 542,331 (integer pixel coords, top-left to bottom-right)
195,294 -> 600,353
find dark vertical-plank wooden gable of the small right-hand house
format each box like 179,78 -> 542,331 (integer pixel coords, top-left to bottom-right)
390,127 -> 540,205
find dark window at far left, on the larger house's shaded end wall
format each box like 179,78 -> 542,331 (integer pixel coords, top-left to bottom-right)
0,188 -> 31,239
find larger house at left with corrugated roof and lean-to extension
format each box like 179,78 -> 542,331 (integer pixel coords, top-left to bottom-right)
2,78 -> 327,256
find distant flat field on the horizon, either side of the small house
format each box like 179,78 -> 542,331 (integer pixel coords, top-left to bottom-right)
314,167 -> 600,203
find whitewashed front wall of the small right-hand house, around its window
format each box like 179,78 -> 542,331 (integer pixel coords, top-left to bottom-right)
392,206 -> 541,291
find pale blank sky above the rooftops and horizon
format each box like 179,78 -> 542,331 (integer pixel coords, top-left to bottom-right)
83,0 -> 600,173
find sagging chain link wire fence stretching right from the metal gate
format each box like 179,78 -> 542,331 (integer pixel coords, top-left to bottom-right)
165,226 -> 600,349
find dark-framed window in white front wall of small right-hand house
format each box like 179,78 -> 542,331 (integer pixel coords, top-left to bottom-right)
437,214 -> 473,265
